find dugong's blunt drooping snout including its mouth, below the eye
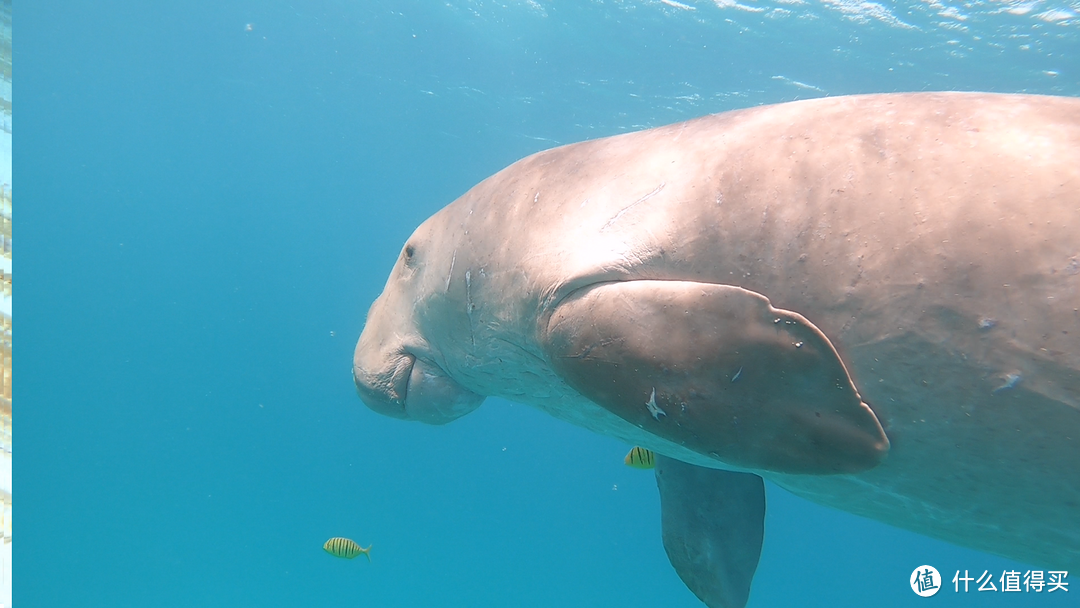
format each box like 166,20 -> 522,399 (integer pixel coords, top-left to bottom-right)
352,301 -> 484,424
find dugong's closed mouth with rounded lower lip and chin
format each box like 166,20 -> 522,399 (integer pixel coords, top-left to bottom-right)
352,347 -> 484,424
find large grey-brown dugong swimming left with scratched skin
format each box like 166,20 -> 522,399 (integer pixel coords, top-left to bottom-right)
353,93 -> 1080,608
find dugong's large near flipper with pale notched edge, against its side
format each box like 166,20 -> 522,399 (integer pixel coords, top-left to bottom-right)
542,280 -> 889,474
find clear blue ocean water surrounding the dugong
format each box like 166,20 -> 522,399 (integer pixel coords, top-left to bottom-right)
21,0 -> 1080,607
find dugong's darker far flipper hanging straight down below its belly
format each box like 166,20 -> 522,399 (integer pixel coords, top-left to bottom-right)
656,455 -> 765,608
